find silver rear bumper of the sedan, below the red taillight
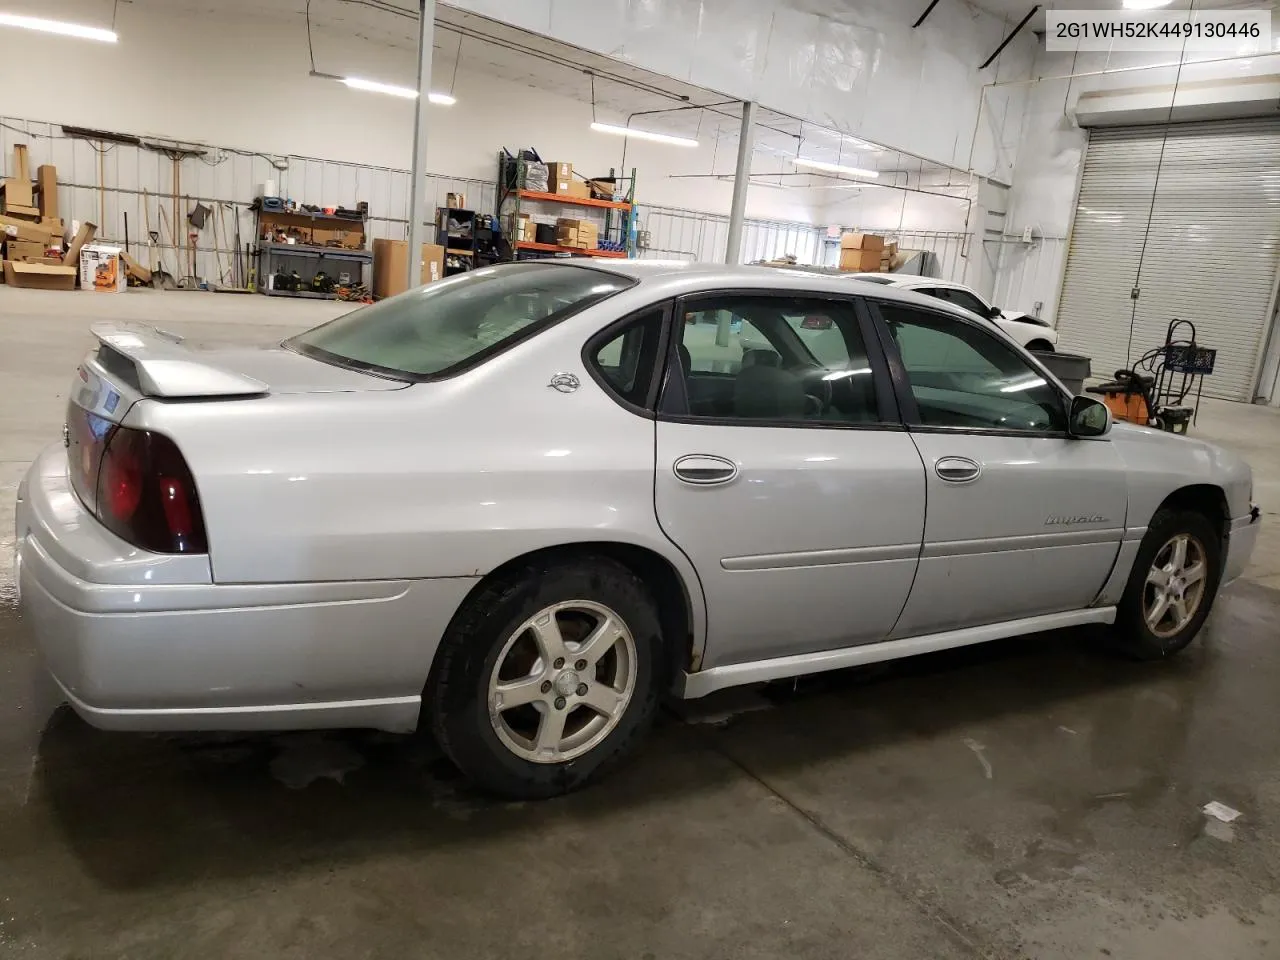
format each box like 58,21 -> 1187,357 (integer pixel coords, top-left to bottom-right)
15,447 -> 475,731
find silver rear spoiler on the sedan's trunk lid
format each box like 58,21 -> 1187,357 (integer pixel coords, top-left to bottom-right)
90,323 -> 268,398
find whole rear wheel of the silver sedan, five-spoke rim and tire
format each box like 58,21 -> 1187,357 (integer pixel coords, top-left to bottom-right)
424,557 -> 664,799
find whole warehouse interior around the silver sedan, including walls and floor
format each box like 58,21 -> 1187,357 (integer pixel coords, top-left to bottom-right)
0,0 -> 1280,960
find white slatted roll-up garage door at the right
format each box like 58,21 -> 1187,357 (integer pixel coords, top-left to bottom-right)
1059,118 -> 1280,401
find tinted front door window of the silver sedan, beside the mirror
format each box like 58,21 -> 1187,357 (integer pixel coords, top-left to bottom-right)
879,303 -> 1066,431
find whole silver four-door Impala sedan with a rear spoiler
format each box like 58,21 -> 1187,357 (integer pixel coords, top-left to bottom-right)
17,260 -> 1258,796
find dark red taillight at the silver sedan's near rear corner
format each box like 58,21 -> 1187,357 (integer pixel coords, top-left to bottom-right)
97,426 -> 209,553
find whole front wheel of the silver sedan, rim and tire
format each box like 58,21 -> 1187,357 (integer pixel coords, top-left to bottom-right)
1115,511 -> 1222,660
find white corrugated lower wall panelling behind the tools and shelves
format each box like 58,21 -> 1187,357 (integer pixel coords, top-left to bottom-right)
0,118 -> 964,291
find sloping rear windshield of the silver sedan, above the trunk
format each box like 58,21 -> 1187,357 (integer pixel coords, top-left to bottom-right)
284,264 -> 634,380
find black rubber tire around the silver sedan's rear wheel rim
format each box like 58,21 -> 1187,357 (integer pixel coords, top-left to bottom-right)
424,556 -> 667,800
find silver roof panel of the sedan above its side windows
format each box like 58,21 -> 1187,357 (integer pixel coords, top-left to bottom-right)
570,257 -> 973,320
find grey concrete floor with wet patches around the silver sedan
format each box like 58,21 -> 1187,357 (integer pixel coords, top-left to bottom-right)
0,287 -> 1280,960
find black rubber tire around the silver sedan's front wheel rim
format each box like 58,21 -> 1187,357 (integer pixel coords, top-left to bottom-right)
1112,509 -> 1222,660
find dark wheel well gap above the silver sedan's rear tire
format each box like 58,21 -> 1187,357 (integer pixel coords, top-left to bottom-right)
467,540 -> 694,677
